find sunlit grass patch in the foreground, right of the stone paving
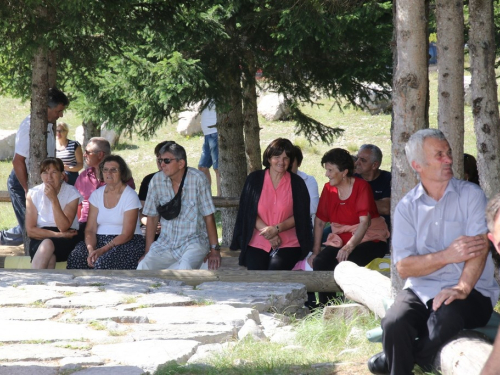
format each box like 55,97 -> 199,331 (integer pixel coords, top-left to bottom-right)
155,311 -> 381,375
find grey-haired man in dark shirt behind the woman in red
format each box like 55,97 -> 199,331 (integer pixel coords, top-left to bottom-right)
354,144 -> 391,231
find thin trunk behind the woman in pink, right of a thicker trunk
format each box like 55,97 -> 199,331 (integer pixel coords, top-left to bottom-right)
243,54 -> 262,173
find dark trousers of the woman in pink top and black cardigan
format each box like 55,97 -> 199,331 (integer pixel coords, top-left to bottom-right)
246,246 -> 302,271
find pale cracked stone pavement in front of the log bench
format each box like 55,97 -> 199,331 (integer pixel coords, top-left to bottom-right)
0,271 -> 307,375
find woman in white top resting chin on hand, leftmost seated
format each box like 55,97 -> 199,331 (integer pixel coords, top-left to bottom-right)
26,158 -> 82,269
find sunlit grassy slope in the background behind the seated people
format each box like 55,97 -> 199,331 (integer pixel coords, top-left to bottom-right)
0,68 -> 477,231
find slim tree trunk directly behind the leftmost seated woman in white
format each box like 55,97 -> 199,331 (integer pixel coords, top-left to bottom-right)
28,47 -> 49,188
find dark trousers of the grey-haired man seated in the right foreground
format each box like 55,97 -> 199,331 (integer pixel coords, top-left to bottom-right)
382,289 -> 493,375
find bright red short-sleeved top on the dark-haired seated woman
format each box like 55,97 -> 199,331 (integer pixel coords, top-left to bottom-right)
316,177 -> 380,244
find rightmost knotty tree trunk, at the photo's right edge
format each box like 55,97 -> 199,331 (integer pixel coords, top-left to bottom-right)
468,0 -> 500,198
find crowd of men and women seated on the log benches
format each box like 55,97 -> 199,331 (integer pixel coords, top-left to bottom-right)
17,129 -> 500,375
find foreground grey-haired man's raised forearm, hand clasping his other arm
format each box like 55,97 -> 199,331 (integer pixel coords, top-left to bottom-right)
396,235 -> 488,281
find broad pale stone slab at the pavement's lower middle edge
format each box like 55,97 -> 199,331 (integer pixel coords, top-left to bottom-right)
92,340 -> 200,374
